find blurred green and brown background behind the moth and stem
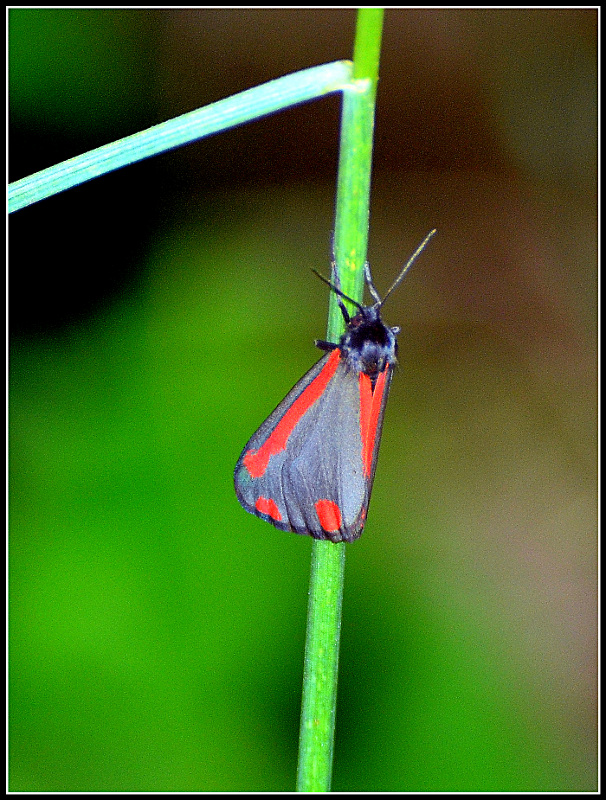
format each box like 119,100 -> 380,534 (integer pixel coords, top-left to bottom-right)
9,9 -> 597,792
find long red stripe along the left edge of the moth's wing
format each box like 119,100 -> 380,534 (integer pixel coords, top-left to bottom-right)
244,348 -> 341,478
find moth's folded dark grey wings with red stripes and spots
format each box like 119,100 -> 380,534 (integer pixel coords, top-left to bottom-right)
234,350 -> 393,542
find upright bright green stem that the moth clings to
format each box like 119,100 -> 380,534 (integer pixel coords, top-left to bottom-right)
297,8 -> 383,792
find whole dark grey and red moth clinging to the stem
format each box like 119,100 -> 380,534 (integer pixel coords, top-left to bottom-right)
234,230 -> 435,542
